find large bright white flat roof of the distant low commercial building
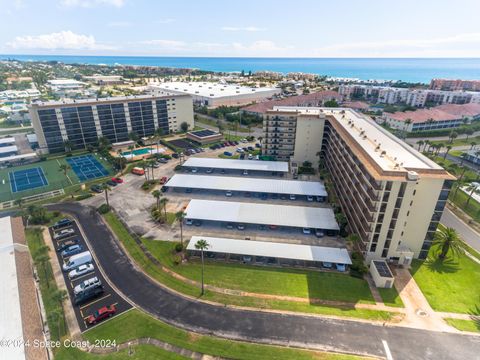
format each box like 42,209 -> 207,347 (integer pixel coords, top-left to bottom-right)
154,81 -> 281,98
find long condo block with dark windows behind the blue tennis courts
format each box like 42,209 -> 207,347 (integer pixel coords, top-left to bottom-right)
29,95 -> 193,153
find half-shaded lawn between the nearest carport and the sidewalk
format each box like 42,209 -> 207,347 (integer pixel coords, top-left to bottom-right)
143,240 -> 375,303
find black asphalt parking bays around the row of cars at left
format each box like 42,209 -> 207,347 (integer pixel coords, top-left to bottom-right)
49,222 -> 132,332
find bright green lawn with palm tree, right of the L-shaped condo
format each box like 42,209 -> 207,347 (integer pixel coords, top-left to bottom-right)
411,246 -> 480,314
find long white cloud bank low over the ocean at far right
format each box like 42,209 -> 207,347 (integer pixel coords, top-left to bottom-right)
314,33 -> 480,57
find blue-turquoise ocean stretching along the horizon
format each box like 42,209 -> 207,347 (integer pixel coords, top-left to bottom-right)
0,55 -> 480,83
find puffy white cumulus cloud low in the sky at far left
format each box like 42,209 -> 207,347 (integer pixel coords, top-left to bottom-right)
7,30 -> 114,50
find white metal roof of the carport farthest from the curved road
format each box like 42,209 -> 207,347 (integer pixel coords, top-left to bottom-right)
183,157 -> 288,172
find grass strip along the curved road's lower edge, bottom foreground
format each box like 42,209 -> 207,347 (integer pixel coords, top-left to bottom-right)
75,310 -> 359,360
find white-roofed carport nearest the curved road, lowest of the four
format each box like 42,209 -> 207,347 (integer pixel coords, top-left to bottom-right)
187,236 -> 352,267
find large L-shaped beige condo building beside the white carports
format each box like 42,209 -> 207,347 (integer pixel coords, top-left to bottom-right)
262,107 -> 455,264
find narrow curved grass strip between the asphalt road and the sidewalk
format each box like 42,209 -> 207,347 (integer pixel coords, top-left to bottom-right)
104,213 -> 393,321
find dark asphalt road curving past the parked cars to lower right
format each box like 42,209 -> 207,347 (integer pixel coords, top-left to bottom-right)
51,203 -> 480,360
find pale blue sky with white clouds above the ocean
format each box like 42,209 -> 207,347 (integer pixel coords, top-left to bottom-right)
0,0 -> 480,57
